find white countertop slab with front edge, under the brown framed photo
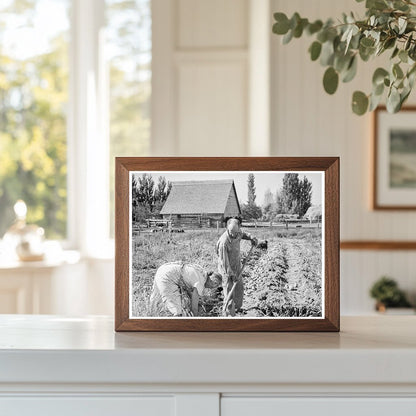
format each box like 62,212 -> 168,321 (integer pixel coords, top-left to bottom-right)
0,315 -> 416,385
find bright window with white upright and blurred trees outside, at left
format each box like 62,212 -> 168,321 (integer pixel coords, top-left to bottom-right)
0,0 -> 152,250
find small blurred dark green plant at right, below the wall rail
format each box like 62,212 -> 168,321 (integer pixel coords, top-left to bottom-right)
370,276 -> 411,312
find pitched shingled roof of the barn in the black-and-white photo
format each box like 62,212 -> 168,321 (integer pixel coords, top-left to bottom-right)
160,179 -> 239,215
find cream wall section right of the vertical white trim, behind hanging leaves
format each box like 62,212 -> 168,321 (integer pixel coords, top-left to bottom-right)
271,0 -> 416,314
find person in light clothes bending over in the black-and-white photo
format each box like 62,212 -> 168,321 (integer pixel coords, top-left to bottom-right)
150,262 -> 222,316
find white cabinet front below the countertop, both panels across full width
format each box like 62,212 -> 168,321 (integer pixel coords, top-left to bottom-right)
4,393 -> 416,416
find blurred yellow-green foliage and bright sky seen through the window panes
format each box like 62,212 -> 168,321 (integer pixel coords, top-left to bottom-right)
0,0 -> 152,239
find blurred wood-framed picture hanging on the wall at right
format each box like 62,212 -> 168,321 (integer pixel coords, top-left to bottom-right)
373,107 -> 416,210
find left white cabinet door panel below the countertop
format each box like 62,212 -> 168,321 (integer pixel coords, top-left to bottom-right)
0,396 -> 175,416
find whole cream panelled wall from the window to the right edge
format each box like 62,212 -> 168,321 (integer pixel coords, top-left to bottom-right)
152,0 -> 416,314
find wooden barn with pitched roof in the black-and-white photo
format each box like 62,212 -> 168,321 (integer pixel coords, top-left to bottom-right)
160,179 -> 241,228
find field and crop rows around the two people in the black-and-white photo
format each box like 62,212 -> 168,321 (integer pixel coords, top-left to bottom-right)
132,228 -> 322,317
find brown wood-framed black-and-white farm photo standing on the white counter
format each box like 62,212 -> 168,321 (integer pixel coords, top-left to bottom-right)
115,157 -> 339,331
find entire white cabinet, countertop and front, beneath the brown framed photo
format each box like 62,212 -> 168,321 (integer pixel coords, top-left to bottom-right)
0,315 -> 416,416
